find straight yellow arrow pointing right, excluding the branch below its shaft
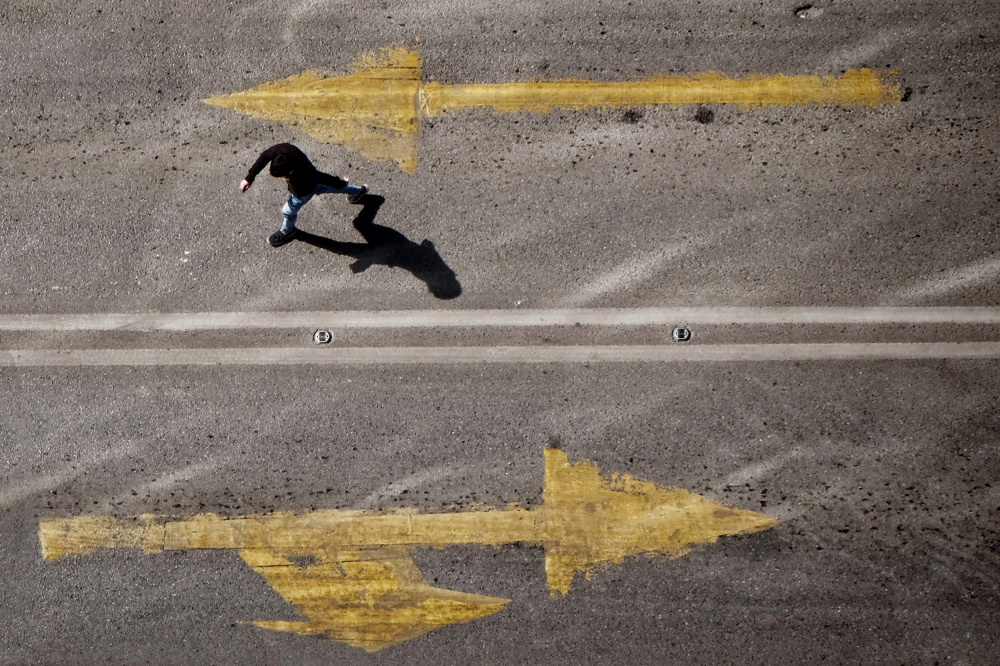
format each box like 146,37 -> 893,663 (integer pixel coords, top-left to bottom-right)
39,449 -> 777,594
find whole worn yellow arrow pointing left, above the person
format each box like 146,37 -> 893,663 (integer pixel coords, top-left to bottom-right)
204,47 -> 901,173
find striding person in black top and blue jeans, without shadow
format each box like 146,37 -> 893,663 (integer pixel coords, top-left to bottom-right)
240,143 -> 368,247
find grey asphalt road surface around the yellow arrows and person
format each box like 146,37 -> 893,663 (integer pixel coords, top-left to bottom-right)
0,0 -> 1000,664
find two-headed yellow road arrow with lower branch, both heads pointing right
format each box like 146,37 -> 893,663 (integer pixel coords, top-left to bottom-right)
39,449 -> 777,651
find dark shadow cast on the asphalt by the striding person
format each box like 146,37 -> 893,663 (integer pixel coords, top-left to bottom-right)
295,194 -> 462,299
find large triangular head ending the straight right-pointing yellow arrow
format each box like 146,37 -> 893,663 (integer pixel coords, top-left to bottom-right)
543,449 -> 778,594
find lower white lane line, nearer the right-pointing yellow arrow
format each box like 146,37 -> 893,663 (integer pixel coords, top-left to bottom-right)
0,342 -> 1000,367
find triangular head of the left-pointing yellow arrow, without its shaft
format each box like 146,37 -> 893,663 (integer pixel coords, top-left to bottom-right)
203,47 -> 422,173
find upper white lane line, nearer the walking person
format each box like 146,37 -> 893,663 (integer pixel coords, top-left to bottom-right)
0,307 -> 1000,332
